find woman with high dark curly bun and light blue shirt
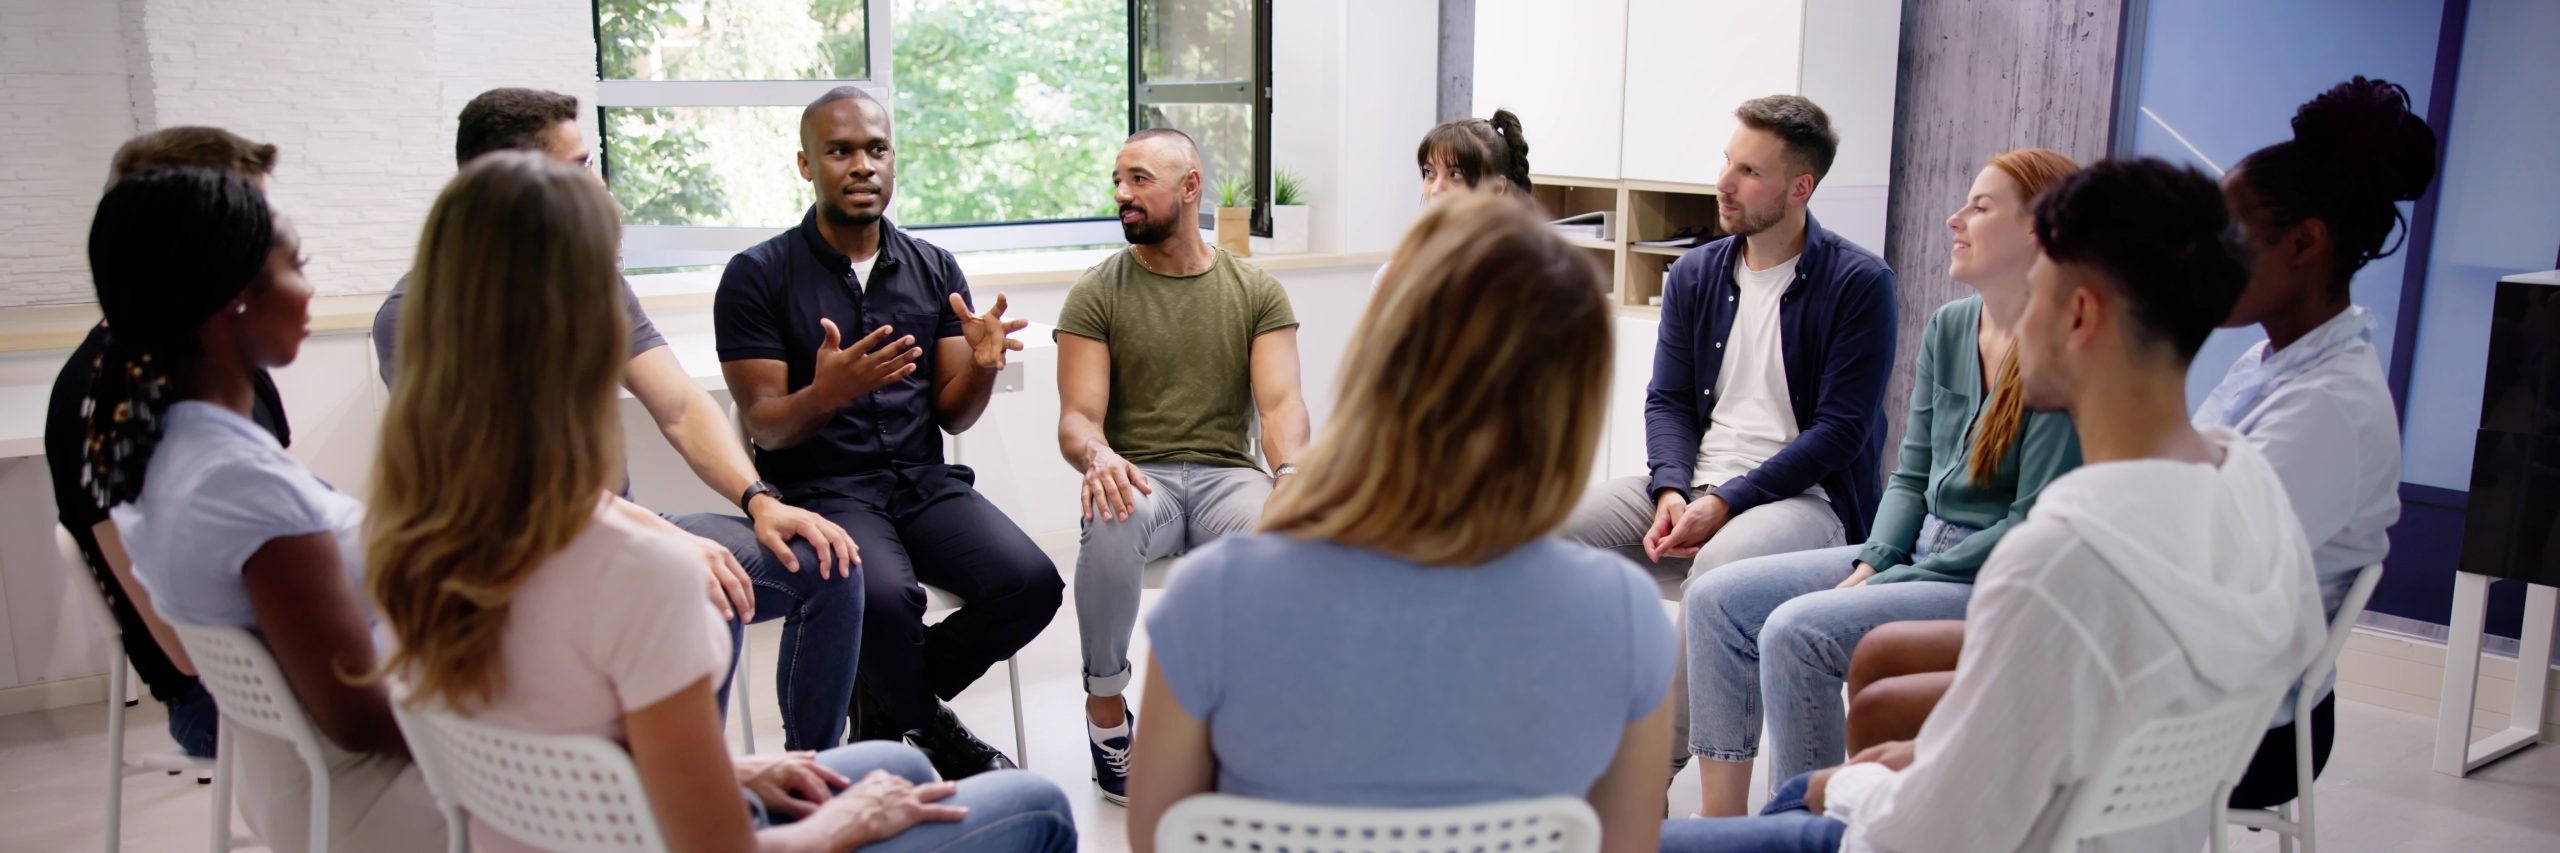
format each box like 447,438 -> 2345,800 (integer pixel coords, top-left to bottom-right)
2196,77 -> 2437,809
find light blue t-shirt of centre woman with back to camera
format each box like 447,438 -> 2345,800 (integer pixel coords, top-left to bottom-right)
1147,533 -> 1677,807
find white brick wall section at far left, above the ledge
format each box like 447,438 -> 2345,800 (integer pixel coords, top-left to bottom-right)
0,0 -> 133,305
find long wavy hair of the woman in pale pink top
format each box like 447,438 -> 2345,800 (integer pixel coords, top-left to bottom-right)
366,151 -> 630,707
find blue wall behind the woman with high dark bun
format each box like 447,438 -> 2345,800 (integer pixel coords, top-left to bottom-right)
2117,0 -> 2447,409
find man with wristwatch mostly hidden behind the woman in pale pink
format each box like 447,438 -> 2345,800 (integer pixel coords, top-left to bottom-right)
374,90 -> 863,751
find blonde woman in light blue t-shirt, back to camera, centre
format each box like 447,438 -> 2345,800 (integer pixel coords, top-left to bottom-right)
1129,195 -> 1674,850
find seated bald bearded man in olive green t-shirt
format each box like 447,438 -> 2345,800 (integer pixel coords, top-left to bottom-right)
1057,131 -> 1308,804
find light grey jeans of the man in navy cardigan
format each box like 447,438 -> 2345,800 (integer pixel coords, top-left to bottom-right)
1564,476 -> 1846,768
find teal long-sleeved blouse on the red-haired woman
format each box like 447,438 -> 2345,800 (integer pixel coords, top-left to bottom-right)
1859,297 -> 2079,584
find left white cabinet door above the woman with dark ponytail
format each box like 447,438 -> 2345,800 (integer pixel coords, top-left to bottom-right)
1474,0 -> 1626,179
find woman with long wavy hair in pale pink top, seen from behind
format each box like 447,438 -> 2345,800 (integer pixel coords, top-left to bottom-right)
366,151 -> 1075,850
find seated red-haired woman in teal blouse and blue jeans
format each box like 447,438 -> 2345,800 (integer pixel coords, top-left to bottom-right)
1682,149 -> 2081,817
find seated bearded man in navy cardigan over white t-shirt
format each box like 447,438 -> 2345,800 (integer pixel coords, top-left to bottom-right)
1564,95 -> 1894,763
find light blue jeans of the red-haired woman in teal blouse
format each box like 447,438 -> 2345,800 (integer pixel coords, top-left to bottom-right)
1682,515 -> 1974,779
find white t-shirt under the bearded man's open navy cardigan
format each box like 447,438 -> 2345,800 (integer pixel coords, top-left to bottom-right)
1692,251 -> 1825,497
